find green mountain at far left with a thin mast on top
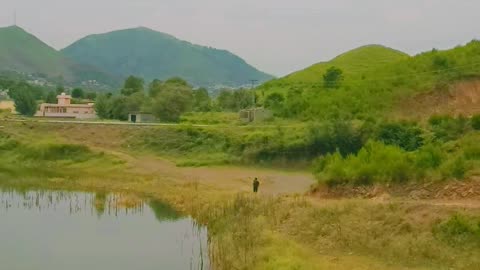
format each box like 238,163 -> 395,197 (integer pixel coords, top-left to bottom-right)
0,26 -> 119,85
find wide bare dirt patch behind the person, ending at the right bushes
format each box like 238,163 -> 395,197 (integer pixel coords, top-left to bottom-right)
107,149 -> 315,195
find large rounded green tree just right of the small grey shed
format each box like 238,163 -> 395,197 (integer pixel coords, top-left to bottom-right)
152,84 -> 193,122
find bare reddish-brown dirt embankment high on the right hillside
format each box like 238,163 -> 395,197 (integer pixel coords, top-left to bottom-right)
397,80 -> 480,119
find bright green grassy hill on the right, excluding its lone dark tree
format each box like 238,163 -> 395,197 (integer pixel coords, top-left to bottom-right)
258,41 -> 480,119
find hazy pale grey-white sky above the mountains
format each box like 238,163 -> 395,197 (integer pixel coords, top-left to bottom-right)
0,0 -> 480,75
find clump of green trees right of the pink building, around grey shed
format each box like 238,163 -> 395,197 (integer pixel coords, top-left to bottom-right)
95,76 -> 255,122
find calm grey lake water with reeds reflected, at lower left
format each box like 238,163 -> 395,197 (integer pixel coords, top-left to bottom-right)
0,190 -> 209,270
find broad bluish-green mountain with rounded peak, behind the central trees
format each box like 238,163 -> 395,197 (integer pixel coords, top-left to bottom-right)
63,28 -> 272,87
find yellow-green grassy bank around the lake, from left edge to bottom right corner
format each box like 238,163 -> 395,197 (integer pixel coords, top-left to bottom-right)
0,122 -> 480,269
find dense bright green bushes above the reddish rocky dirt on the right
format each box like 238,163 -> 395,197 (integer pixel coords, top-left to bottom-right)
314,116 -> 480,185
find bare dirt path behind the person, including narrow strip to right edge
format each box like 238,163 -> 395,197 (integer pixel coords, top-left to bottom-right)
98,149 -> 480,210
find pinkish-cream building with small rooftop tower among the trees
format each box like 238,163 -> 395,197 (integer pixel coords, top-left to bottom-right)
35,93 -> 97,119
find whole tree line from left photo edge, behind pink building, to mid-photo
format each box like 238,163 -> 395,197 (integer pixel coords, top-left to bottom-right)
0,76 -> 257,122
